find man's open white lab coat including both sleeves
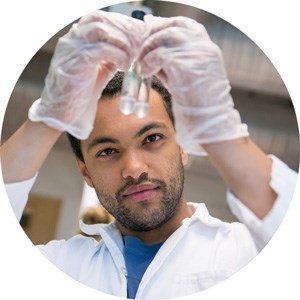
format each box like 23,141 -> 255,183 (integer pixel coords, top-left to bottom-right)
6,156 -> 297,300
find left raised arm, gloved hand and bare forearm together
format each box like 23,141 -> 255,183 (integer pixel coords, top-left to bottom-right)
1,11 -> 143,183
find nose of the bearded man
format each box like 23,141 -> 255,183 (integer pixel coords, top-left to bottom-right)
121,152 -> 149,179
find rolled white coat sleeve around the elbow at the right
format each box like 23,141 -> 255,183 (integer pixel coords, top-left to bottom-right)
227,155 -> 297,250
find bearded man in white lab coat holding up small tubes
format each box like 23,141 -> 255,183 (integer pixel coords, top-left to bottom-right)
1,12 -> 296,299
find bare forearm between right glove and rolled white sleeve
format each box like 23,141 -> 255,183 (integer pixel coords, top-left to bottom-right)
202,137 -> 277,219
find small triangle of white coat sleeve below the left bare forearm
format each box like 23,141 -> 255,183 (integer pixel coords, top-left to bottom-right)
5,174 -> 37,221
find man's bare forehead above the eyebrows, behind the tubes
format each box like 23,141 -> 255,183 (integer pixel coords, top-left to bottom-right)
89,89 -> 174,139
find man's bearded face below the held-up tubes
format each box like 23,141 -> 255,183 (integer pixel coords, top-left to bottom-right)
79,90 -> 186,231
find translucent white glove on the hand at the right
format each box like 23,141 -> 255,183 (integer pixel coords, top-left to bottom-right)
139,15 -> 248,155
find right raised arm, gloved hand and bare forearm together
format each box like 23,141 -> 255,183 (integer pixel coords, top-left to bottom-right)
140,16 -> 296,228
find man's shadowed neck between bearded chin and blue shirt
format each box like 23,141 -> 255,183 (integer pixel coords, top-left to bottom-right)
118,200 -> 193,245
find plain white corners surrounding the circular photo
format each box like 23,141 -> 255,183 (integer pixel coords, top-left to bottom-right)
0,0 -> 300,300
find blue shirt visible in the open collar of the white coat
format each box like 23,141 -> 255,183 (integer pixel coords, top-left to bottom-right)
123,236 -> 163,299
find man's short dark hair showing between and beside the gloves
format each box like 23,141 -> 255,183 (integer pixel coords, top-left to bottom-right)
67,72 -> 175,162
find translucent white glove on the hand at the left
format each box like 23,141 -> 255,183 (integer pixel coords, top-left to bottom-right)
29,11 -> 144,139
